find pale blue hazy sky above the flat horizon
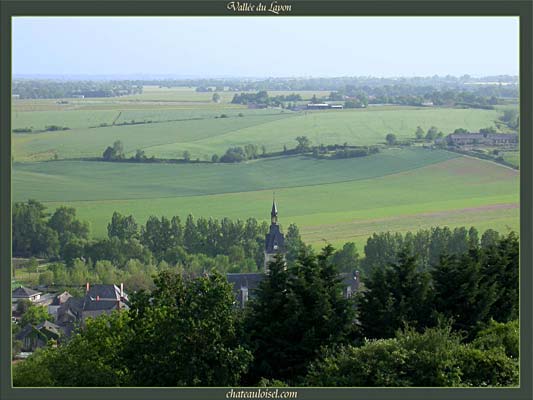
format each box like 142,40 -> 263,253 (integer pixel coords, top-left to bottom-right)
13,17 -> 519,77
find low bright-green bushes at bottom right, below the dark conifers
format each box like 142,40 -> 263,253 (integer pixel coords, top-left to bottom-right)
305,326 -> 518,387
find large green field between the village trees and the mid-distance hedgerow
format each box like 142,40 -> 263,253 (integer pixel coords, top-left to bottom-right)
13,149 -> 519,248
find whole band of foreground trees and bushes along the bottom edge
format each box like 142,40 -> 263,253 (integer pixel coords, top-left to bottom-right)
14,233 -> 519,387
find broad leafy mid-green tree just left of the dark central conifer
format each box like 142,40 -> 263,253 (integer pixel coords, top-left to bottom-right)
124,271 -> 252,386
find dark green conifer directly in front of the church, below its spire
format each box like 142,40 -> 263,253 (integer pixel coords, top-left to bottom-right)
245,246 -> 355,384
